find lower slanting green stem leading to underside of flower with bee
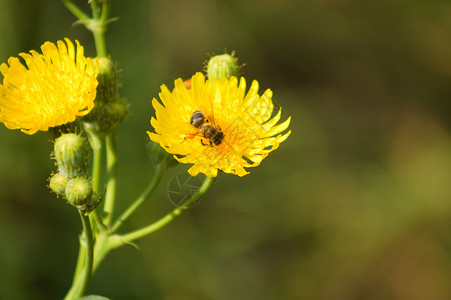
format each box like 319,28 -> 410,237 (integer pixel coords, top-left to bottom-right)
110,177 -> 216,248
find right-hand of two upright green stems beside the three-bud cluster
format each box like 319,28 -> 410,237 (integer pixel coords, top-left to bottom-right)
104,132 -> 117,226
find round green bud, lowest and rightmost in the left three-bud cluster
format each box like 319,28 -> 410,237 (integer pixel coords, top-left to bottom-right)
65,177 -> 92,210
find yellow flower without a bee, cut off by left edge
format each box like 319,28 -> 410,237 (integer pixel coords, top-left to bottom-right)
0,38 -> 98,134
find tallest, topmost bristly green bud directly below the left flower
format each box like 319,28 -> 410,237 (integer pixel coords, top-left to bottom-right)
54,133 -> 89,179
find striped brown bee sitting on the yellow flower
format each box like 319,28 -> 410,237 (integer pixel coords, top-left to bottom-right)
185,110 -> 224,147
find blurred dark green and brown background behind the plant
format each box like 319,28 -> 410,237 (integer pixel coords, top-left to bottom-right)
0,0 -> 451,300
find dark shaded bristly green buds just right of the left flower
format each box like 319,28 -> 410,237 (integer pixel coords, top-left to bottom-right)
84,57 -> 130,135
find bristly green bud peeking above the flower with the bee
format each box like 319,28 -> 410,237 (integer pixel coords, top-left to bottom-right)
207,52 -> 241,80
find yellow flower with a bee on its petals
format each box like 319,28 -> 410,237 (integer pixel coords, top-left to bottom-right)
147,73 -> 291,177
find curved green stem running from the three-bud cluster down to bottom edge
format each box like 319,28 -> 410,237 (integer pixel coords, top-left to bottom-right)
64,210 -> 94,300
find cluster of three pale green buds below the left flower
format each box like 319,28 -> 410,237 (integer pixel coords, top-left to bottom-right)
49,133 -> 98,210
